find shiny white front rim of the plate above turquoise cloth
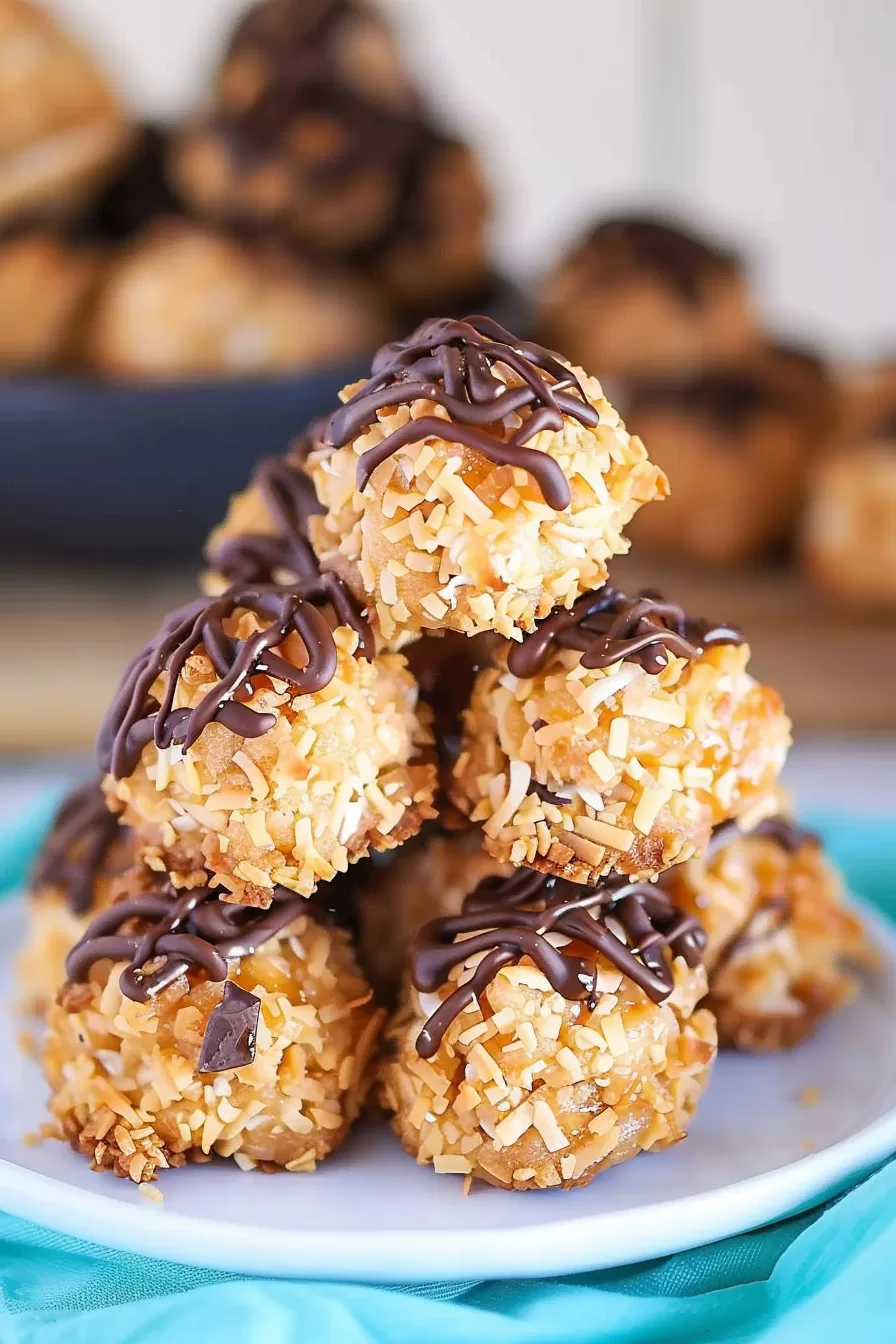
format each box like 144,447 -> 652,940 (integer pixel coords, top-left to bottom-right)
0,898 -> 896,1285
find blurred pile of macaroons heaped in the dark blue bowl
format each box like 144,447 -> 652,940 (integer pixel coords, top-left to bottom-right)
0,0 -> 497,383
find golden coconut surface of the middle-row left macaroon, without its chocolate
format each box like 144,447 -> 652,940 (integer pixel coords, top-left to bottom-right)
105,612 -> 435,906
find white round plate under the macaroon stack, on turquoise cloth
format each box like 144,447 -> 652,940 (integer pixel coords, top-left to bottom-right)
0,902 -> 896,1282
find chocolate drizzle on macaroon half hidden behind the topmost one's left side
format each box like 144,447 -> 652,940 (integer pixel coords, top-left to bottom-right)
210,429 -> 322,585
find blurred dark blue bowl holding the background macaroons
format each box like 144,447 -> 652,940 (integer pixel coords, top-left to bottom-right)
0,358 -> 367,564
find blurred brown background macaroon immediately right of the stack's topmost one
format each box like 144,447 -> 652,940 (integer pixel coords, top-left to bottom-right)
623,352 -> 830,563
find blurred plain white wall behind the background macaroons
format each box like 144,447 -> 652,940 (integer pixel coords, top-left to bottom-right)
52,0 -> 896,356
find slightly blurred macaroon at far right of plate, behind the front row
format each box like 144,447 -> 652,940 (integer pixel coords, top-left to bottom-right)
661,814 -> 870,1051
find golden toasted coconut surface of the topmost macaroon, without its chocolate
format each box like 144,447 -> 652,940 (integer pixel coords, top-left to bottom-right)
308,366 -> 668,648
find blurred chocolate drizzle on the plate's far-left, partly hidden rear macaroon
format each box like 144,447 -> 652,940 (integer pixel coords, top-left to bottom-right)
31,780 -> 124,915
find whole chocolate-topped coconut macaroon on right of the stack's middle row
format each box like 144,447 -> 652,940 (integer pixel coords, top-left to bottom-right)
451,585 -> 790,883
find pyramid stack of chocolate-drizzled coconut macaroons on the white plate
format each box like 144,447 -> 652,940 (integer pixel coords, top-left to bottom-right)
23,317 -> 865,1189
